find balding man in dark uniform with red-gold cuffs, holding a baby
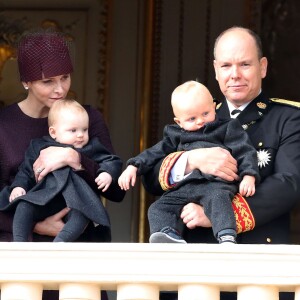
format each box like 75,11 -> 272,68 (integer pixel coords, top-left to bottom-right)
144,27 -> 300,299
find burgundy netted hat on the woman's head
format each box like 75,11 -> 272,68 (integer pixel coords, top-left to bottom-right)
18,31 -> 73,82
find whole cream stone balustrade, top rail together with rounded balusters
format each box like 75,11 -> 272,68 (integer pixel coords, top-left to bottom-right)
0,243 -> 300,300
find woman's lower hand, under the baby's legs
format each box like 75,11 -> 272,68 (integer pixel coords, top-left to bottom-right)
33,207 -> 70,237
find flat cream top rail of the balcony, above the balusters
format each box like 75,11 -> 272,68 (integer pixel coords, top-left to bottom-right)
0,243 -> 300,291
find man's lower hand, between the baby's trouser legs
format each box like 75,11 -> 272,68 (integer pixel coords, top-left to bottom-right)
180,203 -> 211,229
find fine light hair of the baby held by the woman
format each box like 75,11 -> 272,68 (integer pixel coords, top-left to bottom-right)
48,99 -> 87,127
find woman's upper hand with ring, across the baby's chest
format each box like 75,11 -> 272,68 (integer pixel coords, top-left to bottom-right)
33,146 -> 81,182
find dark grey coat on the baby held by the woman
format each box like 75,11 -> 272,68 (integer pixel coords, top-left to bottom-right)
0,136 -> 122,231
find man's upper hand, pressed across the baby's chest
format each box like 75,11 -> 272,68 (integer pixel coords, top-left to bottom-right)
185,147 -> 238,181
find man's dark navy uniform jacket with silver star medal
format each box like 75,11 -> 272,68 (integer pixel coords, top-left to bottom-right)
185,93 -> 300,244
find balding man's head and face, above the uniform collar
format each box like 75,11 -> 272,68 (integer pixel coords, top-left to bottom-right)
214,29 -> 268,106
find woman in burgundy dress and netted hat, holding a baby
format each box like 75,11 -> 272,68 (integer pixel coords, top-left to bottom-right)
0,30 -> 125,299
